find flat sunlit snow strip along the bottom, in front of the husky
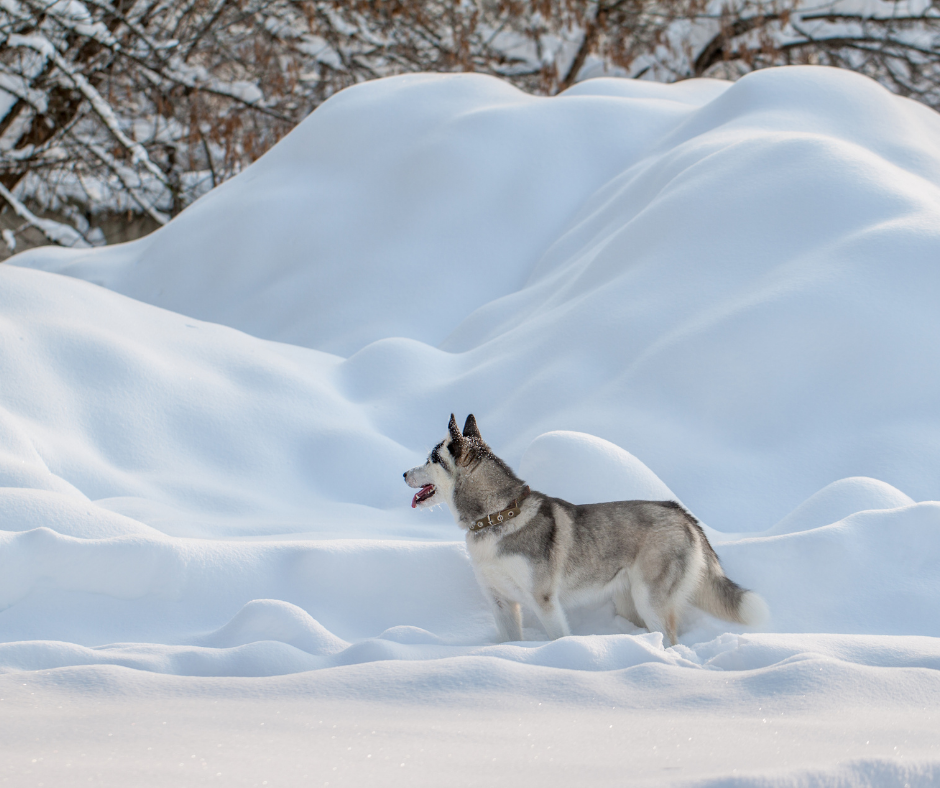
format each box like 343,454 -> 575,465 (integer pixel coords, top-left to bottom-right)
0,647 -> 940,788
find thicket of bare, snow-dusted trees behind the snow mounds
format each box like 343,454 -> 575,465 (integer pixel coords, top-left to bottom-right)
0,0 -> 940,258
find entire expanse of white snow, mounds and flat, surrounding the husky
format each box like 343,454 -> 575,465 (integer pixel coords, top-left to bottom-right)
0,68 -> 940,786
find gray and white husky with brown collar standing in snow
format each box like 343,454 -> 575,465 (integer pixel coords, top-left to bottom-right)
404,414 -> 767,645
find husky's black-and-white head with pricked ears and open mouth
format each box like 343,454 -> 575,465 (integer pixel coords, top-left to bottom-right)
404,413 -> 486,508
